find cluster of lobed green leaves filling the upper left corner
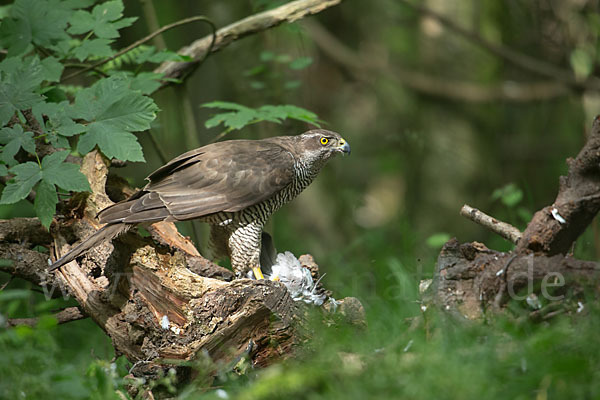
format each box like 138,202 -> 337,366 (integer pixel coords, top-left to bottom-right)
0,0 -> 165,226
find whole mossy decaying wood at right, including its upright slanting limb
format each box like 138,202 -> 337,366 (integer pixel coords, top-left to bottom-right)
434,117 -> 600,318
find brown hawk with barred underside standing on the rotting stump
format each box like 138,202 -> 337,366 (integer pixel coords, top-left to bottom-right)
50,129 -> 350,279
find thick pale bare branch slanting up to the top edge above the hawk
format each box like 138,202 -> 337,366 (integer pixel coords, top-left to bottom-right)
154,0 -> 342,86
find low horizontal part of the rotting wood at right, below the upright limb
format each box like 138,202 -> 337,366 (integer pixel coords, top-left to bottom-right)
430,239 -> 600,319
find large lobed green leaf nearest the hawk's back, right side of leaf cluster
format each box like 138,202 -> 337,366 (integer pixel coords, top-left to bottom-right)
71,75 -> 158,161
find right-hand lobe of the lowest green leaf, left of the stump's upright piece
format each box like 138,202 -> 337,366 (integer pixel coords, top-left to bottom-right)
42,150 -> 90,192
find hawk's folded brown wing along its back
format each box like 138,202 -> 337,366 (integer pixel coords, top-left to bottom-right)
99,140 -> 294,223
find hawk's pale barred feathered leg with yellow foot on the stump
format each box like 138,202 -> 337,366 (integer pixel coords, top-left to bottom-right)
227,222 -> 264,279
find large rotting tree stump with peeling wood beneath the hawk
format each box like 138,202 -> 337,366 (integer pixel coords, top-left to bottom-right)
0,151 -> 364,384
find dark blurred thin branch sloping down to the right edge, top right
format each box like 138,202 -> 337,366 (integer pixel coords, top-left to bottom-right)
399,0 -> 600,91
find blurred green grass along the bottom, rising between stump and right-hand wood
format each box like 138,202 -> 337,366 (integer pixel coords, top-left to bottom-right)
0,220 -> 600,400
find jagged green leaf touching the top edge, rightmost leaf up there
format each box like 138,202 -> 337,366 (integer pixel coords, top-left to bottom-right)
68,0 -> 137,39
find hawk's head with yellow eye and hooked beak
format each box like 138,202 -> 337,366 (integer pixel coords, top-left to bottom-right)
296,129 -> 350,166
